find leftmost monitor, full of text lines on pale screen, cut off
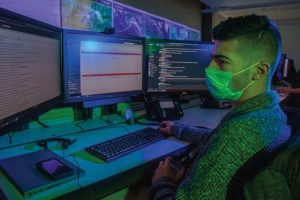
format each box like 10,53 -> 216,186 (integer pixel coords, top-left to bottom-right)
0,9 -> 61,133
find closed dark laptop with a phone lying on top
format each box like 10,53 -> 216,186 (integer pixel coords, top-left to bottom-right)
0,150 -> 84,197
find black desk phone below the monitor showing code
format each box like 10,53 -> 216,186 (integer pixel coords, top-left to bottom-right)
145,96 -> 183,121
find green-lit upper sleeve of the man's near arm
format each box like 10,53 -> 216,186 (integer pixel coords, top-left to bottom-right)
176,119 -> 265,200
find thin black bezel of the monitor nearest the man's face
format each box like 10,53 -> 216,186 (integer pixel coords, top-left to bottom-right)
145,38 -> 215,95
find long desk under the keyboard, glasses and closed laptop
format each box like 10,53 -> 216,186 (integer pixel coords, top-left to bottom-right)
0,107 -> 228,200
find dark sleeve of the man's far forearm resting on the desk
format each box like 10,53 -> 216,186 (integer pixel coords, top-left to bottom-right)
171,123 -> 213,145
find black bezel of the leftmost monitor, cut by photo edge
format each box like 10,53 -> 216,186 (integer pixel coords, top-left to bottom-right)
0,8 -> 63,136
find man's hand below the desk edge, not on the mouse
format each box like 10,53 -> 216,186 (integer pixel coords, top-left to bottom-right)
152,157 -> 185,183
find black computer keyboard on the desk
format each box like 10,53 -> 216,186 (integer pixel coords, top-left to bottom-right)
85,128 -> 164,162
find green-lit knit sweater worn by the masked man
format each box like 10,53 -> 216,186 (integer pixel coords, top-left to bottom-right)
149,91 -> 289,200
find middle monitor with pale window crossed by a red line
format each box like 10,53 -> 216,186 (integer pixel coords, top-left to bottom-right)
63,30 -> 145,108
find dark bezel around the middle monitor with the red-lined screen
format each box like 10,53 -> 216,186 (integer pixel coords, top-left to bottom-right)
62,29 -> 147,108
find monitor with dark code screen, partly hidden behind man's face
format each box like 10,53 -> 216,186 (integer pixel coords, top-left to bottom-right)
146,39 -> 214,93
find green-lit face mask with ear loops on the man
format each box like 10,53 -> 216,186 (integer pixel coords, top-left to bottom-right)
205,62 -> 259,101
